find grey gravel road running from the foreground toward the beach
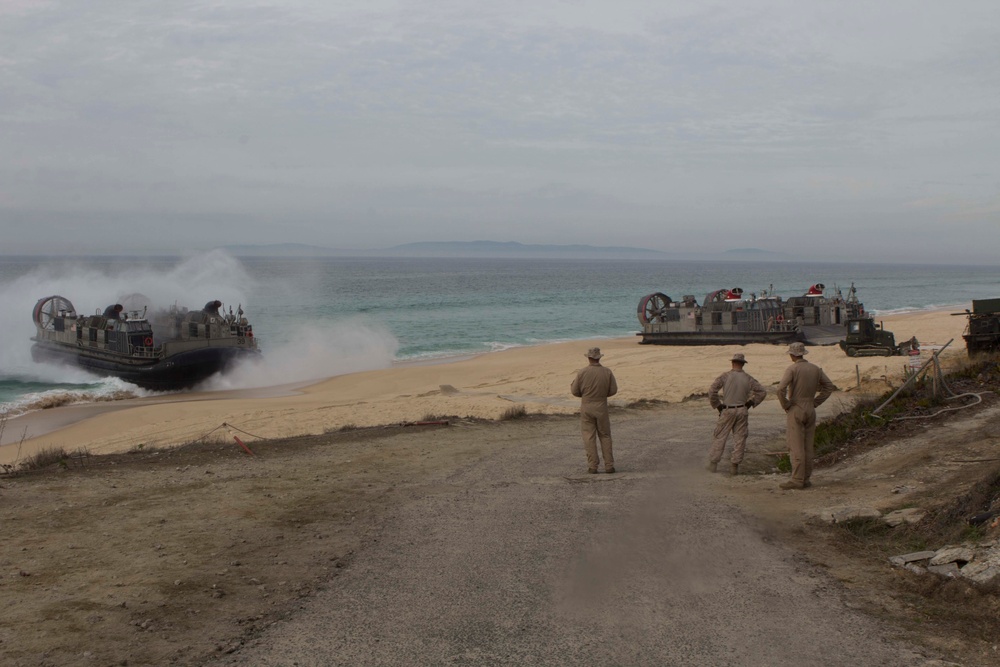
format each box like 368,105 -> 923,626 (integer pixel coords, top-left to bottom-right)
218,406 -> 924,667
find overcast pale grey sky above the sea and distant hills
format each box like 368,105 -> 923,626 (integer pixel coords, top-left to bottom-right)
0,0 -> 1000,264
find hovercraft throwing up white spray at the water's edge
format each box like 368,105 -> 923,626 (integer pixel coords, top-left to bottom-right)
31,295 -> 260,391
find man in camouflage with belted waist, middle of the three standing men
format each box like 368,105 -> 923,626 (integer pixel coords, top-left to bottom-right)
708,352 -> 767,475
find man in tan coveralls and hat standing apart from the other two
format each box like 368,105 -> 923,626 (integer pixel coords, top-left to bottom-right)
570,347 -> 618,473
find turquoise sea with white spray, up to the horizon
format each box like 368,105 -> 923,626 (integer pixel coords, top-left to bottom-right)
0,251 -> 1000,415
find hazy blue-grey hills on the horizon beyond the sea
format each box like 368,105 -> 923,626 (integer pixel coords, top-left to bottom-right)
222,241 -> 788,261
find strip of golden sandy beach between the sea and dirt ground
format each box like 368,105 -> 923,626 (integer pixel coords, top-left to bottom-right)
0,305 -> 967,464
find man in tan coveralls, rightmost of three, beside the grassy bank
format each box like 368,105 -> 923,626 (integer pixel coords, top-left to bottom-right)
778,343 -> 836,489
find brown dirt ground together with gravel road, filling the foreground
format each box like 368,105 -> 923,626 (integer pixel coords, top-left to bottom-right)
0,402 -> 988,666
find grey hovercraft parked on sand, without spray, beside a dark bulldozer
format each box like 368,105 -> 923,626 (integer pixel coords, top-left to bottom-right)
636,283 -> 866,345
